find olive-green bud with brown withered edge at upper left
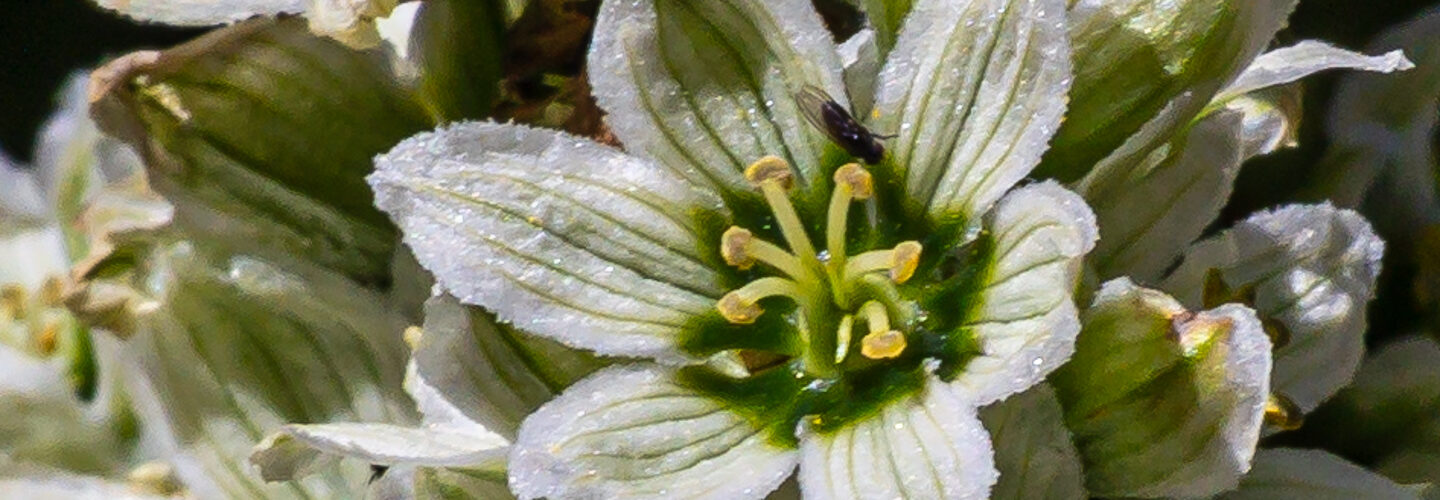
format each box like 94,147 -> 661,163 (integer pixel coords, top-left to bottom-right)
94,19 -> 429,284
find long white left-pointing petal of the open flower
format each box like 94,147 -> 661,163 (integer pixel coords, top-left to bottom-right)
369,122 -> 723,362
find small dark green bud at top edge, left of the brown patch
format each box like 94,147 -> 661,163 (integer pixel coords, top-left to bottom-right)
410,0 -> 505,122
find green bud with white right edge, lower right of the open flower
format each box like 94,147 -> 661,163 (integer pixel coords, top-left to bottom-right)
1050,278 -> 1270,497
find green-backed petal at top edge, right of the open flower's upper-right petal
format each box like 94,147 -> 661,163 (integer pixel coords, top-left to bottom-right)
1035,0 -> 1296,182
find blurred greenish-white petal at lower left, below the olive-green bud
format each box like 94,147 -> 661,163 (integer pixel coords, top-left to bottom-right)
110,242 -> 413,497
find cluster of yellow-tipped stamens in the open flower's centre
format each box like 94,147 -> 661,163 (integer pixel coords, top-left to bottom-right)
716,157 -> 922,378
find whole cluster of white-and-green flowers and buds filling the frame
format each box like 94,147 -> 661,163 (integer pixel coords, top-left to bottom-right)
0,0 -> 1440,499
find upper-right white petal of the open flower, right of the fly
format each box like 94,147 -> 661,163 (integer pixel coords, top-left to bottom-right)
873,0 -> 1070,220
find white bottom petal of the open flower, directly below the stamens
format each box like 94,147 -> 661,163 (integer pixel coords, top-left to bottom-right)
799,379 -> 996,500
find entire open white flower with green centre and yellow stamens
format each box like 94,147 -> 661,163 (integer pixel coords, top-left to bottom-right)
354,0 -> 1094,499
